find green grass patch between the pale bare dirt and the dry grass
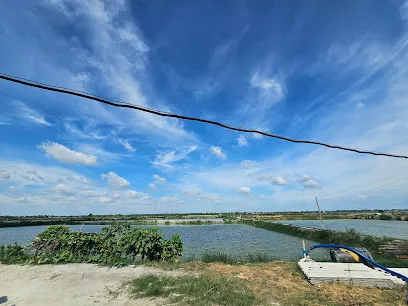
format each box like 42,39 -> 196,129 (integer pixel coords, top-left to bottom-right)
129,273 -> 260,306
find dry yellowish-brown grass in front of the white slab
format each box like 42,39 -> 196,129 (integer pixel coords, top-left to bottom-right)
186,262 -> 406,306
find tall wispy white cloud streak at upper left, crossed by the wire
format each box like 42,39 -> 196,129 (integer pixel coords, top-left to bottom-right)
43,0 -> 196,142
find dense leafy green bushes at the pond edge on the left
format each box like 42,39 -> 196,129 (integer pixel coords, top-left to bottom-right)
0,223 -> 183,265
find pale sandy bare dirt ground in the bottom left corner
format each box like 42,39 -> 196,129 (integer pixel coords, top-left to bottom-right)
0,264 -> 180,306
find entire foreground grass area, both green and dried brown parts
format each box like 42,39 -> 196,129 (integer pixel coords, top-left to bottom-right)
127,261 -> 405,306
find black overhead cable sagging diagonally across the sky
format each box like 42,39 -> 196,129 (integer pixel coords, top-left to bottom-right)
0,73 -> 408,159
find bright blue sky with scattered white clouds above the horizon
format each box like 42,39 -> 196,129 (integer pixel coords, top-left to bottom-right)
0,0 -> 408,215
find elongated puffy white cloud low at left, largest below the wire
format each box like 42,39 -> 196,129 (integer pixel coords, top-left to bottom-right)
38,141 -> 97,166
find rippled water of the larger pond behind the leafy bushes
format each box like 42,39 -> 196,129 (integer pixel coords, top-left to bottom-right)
0,224 -> 326,260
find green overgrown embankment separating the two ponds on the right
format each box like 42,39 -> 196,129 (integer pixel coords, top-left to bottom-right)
241,220 -> 408,267
